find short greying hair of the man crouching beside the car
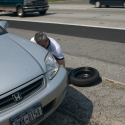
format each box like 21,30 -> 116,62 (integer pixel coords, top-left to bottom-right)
34,32 -> 48,43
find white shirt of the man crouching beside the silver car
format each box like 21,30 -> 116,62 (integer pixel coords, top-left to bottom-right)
31,37 -> 64,60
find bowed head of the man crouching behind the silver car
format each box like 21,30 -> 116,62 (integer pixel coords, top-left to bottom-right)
34,32 -> 49,48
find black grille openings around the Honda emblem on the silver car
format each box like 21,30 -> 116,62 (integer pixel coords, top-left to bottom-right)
0,78 -> 43,110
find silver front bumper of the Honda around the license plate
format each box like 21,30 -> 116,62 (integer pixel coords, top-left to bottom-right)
0,67 -> 67,125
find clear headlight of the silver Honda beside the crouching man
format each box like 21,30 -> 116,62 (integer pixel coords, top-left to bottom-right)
45,53 -> 59,79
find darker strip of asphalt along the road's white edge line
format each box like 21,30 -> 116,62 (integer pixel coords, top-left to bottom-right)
1,20 -> 125,43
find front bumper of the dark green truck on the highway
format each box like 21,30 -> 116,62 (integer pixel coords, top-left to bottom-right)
23,5 -> 49,12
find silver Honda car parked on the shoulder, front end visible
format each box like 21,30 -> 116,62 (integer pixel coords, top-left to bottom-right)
0,21 -> 67,125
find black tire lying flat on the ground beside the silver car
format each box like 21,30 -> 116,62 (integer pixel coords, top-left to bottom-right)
68,67 -> 100,87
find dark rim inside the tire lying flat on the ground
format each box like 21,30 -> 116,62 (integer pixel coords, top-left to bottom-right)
73,70 -> 93,79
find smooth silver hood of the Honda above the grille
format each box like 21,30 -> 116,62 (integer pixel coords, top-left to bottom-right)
0,33 -> 48,95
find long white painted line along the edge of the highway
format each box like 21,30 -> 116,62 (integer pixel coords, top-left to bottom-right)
2,18 -> 125,30
